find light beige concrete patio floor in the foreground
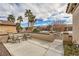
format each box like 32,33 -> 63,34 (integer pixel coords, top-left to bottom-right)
4,38 -> 64,56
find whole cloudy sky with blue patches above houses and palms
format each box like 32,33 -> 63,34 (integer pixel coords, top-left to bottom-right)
0,3 -> 72,27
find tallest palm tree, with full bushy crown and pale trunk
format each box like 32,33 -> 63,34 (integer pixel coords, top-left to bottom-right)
25,9 -> 35,27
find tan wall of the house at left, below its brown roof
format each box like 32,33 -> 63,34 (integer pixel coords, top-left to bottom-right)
0,25 -> 16,33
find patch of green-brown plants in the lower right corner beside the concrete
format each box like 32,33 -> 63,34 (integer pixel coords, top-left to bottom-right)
63,42 -> 79,56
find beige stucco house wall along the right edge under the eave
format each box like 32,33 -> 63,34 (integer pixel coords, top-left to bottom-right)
73,6 -> 79,44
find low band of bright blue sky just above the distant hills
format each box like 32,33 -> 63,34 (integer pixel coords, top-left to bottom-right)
21,16 -> 72,27
